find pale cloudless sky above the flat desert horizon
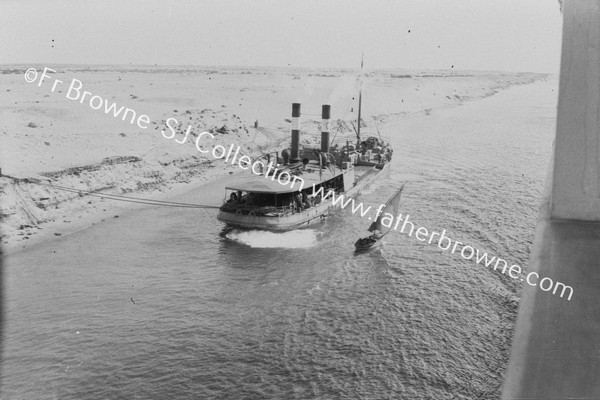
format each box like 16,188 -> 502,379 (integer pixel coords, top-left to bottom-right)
0,0 -> 562,73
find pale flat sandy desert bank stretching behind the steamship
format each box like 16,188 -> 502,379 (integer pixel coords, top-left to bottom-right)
0,66 -> 548,254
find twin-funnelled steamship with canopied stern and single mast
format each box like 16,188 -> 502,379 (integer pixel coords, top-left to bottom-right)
217,85 -> 392,231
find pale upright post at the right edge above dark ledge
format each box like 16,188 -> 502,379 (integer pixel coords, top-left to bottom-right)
551,0 -> 600,221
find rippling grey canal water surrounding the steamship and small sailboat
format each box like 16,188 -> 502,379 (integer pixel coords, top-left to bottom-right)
2,80 -> 554,399
